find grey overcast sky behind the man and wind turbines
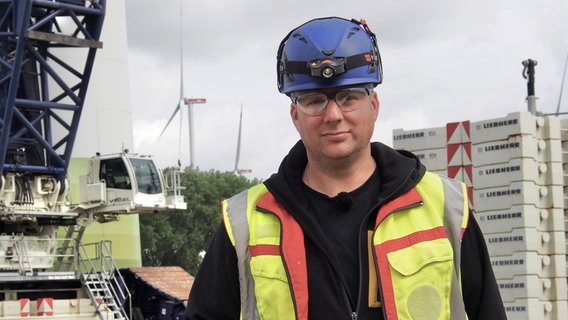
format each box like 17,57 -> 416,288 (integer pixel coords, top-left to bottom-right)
123,0 -> 568,179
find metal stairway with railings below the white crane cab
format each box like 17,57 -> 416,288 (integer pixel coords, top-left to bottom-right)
79,240 -> 132,320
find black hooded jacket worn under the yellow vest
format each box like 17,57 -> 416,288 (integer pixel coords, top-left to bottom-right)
185,141 -> 506,320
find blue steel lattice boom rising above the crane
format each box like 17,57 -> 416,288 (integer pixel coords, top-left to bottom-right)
0,0 -> 105,182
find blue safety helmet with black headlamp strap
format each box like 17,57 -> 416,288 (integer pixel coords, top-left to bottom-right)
276,17 -> 383,95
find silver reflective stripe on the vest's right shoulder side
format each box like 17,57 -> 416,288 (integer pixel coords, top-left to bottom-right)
440,176 -> 468,320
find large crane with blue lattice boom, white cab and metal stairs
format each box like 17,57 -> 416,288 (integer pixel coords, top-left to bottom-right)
0,0 -> 186,319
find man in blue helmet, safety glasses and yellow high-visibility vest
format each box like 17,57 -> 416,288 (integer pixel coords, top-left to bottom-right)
185,17 -> 505,320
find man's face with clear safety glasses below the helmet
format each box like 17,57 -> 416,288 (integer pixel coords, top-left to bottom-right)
290,86 -> 379,163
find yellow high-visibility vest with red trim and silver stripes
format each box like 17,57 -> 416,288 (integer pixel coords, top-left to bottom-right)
223,172 -> 469,320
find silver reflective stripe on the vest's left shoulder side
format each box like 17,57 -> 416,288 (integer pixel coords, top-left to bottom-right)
226,190 -> 260,320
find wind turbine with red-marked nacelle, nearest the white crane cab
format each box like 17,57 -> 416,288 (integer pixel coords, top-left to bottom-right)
160,1 -> 206,167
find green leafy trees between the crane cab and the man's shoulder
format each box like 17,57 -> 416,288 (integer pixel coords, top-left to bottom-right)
140,167 -> 260,275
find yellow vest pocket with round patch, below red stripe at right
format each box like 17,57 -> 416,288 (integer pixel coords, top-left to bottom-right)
387,239 -> 454,319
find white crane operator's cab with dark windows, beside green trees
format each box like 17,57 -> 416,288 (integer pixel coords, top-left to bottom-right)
79,152 -> 187,213
